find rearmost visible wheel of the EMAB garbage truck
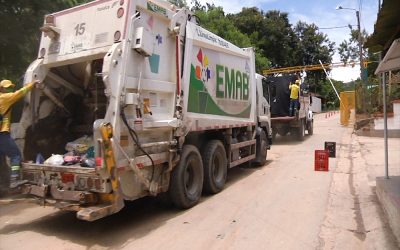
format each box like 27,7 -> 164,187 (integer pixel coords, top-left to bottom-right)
169,145 -> 203,208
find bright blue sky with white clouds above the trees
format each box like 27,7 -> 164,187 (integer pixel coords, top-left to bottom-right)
192,0 -> 382,82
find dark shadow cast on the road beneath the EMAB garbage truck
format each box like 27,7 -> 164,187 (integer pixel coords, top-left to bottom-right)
0,161 -> 272,249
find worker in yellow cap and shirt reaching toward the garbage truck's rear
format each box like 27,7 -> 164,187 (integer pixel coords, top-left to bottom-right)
0,80 -> 39,189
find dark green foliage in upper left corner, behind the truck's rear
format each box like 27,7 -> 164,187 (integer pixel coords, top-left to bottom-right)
0,0 -> 88,81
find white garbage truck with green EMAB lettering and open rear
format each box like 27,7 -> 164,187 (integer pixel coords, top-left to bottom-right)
15,0 -> 271,221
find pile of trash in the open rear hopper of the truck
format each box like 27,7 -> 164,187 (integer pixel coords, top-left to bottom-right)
36,135 -> 96,168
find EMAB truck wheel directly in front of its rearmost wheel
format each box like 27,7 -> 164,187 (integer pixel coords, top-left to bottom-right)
203,140 -> 228,194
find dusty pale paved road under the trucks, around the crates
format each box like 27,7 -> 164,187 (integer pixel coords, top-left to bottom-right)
0,115 -> 396,249
